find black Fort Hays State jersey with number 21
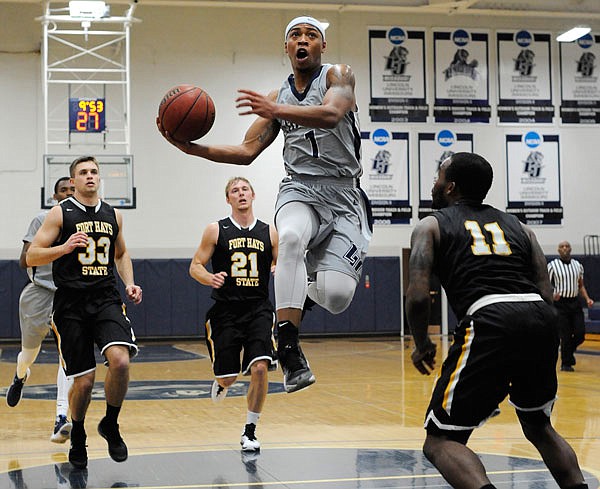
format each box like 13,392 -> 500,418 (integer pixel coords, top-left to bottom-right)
211,217 -> 273,301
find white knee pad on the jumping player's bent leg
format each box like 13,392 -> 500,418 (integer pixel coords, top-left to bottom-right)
308,270 -> 358,314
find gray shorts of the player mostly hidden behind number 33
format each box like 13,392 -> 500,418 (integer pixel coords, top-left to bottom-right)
19,282 -> 54,349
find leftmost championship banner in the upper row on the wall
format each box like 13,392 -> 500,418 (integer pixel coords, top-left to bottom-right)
369,27 -> 429,122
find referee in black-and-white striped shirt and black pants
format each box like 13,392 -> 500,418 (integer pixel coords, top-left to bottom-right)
548,241 -> 594,372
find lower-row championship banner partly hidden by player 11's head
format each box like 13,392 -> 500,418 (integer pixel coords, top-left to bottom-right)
419,129 -> 473,219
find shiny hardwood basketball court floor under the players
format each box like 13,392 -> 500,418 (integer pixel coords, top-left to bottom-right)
0,338 -> 600,489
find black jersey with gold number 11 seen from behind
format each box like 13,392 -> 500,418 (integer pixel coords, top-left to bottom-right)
433,202 -> 540,318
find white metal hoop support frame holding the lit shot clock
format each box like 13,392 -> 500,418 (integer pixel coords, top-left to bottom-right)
36,0 -> 139,207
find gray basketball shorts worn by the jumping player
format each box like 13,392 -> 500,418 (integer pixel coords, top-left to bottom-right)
275,175 -> 372,281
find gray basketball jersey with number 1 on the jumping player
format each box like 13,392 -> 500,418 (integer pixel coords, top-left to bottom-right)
277,64 -> 362,178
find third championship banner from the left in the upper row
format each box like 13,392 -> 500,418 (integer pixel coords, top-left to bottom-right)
496,30 -> 554,124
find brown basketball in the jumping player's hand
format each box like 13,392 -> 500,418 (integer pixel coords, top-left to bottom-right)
158,85 -> 215,142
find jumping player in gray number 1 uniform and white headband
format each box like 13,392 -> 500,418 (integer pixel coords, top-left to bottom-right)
157,17 -> 371,392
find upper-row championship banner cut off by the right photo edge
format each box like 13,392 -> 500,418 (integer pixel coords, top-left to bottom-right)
559,34 -> 600,124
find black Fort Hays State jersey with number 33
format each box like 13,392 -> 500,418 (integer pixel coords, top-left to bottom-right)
52,197 -> 119,289
